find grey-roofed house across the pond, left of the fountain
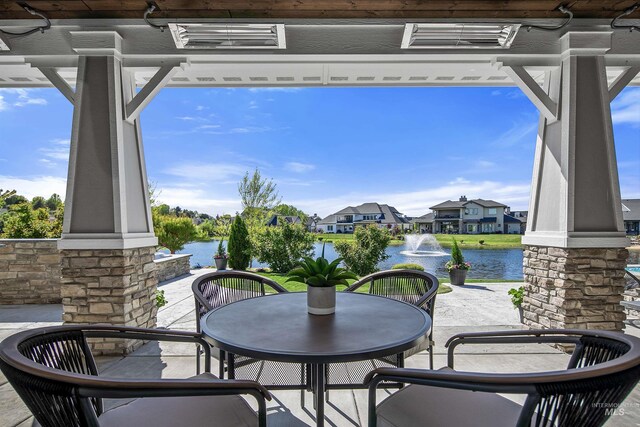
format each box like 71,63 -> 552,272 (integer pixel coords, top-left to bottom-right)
317,203 -> 412,233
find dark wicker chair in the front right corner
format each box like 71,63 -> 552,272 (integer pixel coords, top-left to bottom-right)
365,329 -> 640,427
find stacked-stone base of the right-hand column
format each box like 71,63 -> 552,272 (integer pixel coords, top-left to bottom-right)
522,245 -> 629,331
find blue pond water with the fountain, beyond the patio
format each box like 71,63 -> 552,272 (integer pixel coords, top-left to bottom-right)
169,240 -> 523,281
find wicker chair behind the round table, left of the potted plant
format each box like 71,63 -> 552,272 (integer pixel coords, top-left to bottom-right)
192,270 -> 306,388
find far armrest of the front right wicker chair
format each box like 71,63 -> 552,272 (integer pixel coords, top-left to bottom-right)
444,329 -> 584,368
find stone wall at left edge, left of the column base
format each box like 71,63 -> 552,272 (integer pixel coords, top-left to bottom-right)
0,239 -> 61,304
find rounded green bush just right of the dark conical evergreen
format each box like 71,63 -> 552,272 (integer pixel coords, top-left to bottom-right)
255,222 -> 315,273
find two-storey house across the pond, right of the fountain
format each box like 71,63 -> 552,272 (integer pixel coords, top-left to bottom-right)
422,196 -> 522,234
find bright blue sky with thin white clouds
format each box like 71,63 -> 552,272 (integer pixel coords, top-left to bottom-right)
0,87 -> 640,216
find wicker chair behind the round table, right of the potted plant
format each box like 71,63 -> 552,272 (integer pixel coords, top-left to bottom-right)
346,270 -> 440,369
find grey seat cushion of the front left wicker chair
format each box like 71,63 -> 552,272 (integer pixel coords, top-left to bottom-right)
99,373 -> 258,427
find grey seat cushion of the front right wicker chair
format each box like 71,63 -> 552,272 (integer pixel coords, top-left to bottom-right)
377,385 -> 522,427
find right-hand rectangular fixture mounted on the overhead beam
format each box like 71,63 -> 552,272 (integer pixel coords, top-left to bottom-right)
401,23 -> 520,49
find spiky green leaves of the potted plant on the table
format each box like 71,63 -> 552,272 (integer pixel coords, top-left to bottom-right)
287,256 -> 358,288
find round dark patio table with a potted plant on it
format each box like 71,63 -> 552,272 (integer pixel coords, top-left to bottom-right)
201,292 -> 431,426
